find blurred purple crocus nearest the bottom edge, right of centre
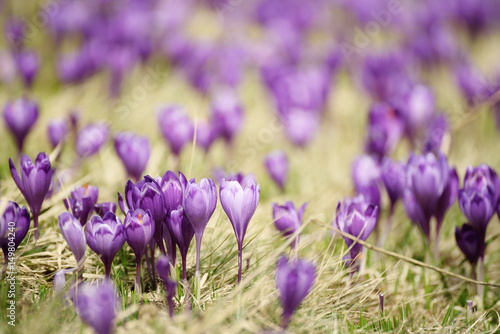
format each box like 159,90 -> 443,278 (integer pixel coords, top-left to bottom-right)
276,256 -> 316,328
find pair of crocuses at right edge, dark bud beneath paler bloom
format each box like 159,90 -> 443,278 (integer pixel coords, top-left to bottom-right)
455,165 -> 500,288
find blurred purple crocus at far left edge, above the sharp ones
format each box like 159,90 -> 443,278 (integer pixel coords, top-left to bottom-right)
3,97 -> 38,153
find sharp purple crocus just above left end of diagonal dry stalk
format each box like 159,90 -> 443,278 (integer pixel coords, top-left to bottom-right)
333,195 -> 378,266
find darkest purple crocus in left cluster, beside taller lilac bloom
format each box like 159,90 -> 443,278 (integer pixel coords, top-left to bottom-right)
167,206 -> 194,279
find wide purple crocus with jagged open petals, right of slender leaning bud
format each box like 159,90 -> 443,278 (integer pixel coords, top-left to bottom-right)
85,212 -> 125,278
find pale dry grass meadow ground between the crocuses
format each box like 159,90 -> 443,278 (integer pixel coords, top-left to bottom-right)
0,33 -> 500,334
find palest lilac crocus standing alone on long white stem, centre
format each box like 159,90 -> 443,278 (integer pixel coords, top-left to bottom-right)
220,180 -> 260,283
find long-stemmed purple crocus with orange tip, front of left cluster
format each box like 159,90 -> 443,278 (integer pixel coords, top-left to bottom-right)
124,209 -> 155,291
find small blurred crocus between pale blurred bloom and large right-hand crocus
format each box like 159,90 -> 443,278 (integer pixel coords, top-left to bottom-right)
381,158 -> 406,209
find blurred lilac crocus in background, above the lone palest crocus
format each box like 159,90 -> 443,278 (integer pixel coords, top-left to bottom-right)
211,89 -> 243,143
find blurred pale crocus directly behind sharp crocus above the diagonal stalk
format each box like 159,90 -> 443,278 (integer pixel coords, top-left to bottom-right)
352,154 -> 381,206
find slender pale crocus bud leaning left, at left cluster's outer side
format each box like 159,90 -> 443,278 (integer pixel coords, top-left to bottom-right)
59,212 -> 87,268
